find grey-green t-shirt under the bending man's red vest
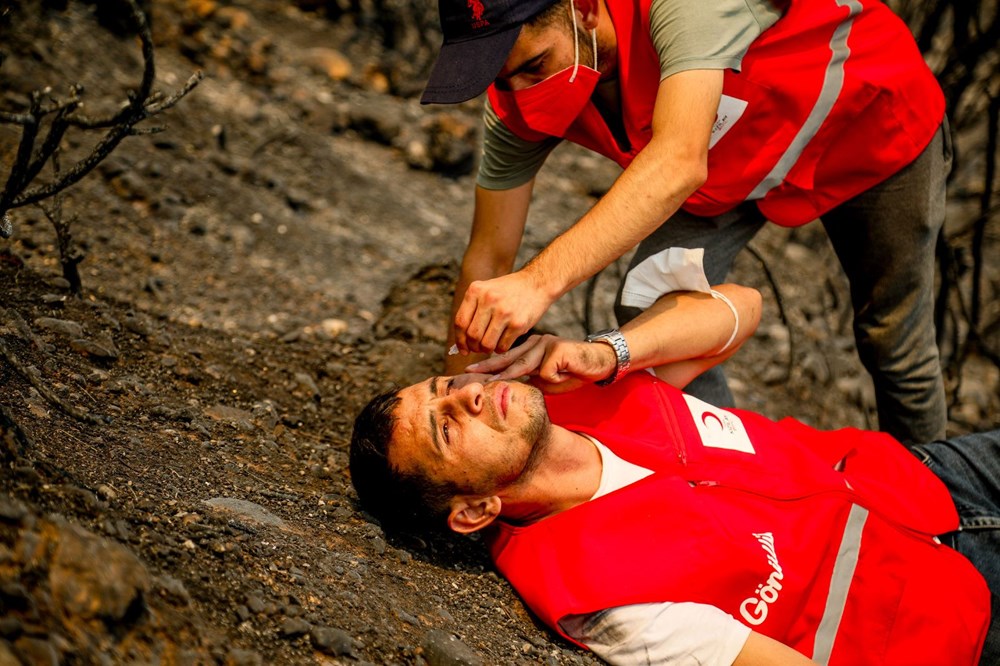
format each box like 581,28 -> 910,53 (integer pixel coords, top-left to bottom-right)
476,0 -> 781,190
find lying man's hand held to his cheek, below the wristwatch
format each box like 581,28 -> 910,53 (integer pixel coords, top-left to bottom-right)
467,335 -> 618,393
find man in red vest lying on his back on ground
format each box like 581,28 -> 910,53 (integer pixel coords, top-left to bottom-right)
351,285 -> 1000,666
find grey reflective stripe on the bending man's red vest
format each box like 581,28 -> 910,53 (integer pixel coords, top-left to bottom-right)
747,0 -> 862,200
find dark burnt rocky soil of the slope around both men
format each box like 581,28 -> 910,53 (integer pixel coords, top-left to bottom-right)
0,0 -> 1000,664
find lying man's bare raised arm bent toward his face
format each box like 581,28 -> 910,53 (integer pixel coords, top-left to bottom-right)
467,284 -> 761,393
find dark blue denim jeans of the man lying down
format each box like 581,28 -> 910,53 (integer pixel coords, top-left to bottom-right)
912,430 -> 1000,666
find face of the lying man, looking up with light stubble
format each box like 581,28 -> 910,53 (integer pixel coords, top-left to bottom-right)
388,374 -> 551,494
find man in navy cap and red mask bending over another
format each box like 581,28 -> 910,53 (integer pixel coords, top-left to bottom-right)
422,0 -> 950,442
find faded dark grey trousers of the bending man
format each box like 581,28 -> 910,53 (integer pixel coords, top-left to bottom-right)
615,122 -> 951,444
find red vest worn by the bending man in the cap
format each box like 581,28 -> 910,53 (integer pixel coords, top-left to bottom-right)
488,0 -> 944,226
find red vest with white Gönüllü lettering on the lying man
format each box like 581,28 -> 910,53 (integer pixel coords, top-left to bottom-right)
489,373 -> 990,666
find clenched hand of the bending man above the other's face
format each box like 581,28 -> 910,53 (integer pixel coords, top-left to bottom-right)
454,270 -> 555,353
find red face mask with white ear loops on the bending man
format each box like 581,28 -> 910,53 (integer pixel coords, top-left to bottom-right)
496,17 -> 601,137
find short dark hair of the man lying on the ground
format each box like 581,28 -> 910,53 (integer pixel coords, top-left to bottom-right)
350,390 -> 460,532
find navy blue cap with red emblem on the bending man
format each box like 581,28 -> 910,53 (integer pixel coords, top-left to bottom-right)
420,0 -> 559,104
